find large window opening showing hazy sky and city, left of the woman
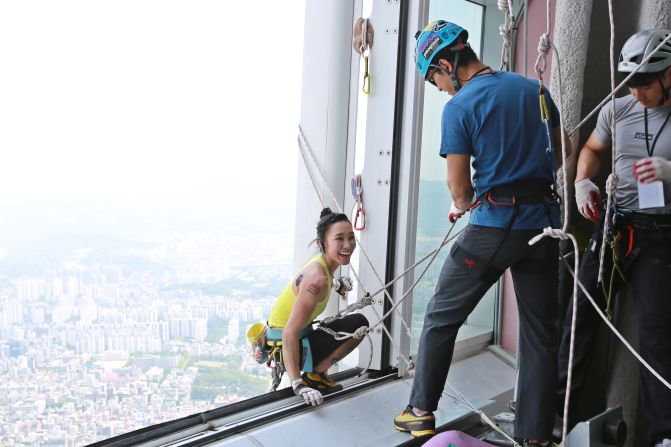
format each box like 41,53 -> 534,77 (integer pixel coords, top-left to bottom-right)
0,0 -> 305,445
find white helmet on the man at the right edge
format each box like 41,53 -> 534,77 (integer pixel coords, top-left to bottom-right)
617,28 -> 671,73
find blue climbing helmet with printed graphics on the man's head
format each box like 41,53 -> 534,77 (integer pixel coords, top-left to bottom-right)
415,20 -> 468,79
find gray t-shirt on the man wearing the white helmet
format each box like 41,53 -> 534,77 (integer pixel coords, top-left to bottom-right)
593,95 -> 671,214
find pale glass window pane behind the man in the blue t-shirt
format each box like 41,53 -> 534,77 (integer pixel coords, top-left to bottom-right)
411,0 -> 496,352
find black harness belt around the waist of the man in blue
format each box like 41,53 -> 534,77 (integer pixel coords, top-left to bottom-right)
484,180 -> 561,206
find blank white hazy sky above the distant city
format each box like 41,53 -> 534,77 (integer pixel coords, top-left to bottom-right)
0,0 -> 304,205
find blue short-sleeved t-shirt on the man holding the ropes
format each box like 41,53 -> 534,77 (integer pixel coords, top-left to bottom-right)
440,72 -> 560,230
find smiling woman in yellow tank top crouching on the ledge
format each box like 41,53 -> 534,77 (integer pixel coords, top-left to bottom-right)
268,208 -> 368,405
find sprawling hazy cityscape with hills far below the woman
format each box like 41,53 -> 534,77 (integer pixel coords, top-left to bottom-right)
0,200 -> 293,447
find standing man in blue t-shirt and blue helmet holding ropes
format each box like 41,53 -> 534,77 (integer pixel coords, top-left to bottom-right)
394,20 -> 562,445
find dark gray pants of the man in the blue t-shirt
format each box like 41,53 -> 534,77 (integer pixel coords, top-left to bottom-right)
410,225 -> 558,440
